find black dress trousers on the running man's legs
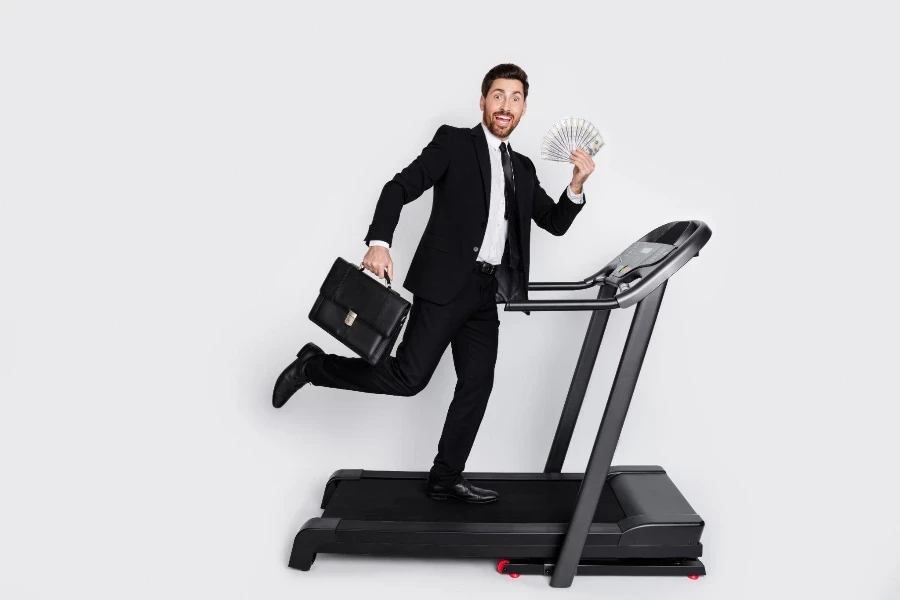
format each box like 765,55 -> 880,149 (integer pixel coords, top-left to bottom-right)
306,267 -> 500,485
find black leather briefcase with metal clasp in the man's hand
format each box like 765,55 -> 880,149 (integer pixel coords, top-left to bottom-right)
309,257 -> 410,365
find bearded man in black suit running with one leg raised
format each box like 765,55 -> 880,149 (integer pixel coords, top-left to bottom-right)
272,64 -> 594,503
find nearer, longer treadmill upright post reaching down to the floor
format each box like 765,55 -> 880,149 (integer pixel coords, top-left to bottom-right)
550,281 -> 668,588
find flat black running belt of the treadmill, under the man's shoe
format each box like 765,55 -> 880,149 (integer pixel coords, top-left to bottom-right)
322,479 -> 625,523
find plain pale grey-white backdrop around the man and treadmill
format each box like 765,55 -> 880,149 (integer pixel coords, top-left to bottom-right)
0,1 -> 900,600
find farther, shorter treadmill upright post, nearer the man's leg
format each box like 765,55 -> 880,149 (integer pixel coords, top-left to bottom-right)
544,285 -> 616,473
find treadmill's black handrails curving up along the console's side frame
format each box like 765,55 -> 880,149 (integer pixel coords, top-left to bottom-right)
504,221 -> 712,311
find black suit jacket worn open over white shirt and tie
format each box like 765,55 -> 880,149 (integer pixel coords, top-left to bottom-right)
365,123 -> 587,304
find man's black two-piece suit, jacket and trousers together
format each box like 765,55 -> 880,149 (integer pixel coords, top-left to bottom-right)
306,124 -> 584,485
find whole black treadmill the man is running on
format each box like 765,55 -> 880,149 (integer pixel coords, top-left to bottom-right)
288,221 -> 712,587
